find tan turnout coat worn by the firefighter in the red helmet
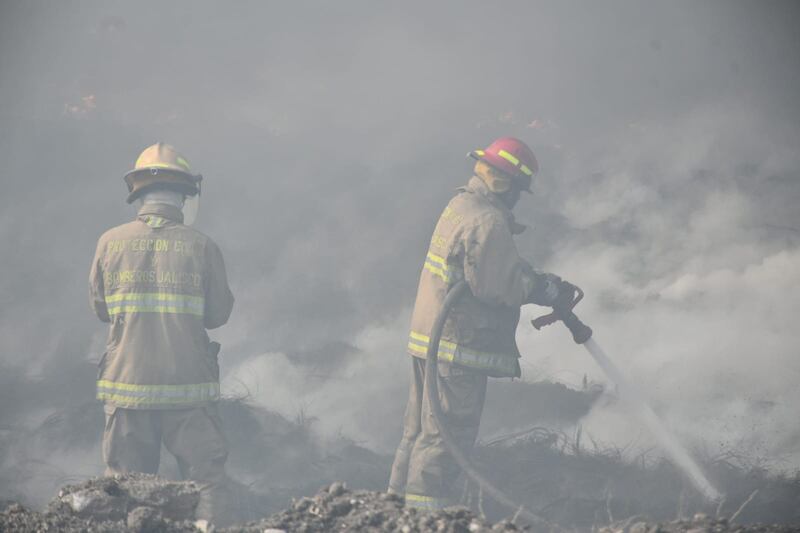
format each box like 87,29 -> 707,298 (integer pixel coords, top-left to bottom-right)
408,177 -> 535,377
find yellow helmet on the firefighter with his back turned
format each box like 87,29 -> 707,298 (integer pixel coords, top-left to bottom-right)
124,142 -> 203,204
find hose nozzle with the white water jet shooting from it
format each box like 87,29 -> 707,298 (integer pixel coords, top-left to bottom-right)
531,282 -> 722,502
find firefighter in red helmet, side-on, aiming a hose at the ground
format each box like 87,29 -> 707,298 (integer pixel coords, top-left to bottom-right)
389,137 -> 561,509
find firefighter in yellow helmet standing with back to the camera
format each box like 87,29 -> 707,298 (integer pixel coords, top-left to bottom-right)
89,143 -> 233,522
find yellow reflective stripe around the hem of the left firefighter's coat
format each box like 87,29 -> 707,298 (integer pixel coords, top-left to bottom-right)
97,379 -> 219,407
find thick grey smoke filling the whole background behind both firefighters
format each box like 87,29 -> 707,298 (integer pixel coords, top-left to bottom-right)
0,1 -> 800,502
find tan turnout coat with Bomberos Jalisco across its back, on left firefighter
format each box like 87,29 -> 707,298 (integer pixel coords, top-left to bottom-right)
89,204 -> 233,409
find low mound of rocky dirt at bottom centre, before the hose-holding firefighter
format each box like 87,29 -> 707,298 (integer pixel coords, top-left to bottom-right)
225,483 -> 521,533
